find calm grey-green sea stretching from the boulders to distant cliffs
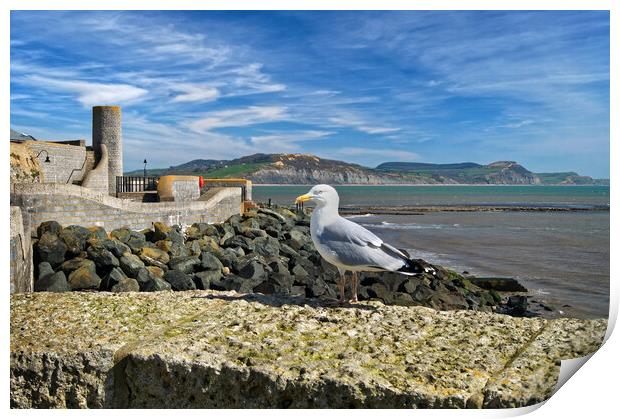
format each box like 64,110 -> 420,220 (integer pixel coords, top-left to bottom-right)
253,186 -> 609,317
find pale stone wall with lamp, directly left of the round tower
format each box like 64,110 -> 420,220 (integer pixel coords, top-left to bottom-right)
25,141 -> 94,183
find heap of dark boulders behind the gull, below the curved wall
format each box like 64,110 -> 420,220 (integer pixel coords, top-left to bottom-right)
33,208 -> 531,316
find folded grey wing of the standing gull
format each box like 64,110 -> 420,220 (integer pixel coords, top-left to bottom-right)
319,218 -> 407,271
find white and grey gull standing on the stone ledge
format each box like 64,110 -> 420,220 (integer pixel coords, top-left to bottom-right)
295,185 -> 435,303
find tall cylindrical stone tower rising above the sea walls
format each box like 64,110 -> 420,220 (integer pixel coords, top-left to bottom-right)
93,106 -> 123,195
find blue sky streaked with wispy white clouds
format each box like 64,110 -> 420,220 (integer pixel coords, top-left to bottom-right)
11,11 -> 609,177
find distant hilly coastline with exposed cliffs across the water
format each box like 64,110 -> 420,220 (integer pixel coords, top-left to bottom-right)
127,154 -> 601,185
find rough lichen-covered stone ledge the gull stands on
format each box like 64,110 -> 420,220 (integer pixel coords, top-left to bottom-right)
11,291 -> 607,408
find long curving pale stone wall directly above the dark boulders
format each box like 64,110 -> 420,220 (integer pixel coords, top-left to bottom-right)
11,183 -> 241,231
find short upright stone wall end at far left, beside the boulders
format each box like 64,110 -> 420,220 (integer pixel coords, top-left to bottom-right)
10,207 -> 33,294
